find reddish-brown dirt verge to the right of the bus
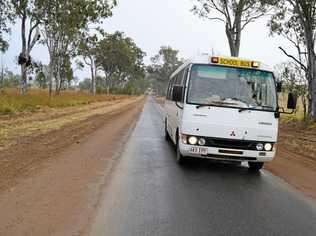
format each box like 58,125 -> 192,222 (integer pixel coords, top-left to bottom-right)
265,123 -> 316,199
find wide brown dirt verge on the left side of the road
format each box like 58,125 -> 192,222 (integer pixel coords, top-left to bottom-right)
0,98 -> 144,235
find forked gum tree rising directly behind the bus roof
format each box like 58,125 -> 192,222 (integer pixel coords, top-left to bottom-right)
192,0 -> 270,57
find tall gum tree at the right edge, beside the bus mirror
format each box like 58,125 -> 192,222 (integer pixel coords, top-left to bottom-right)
270,0 -> 316,119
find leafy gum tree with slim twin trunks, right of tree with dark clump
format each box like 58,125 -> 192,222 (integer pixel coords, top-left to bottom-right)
42,0 -> 116,94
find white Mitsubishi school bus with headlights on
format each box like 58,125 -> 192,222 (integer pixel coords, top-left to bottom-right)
165,56 -> 296,171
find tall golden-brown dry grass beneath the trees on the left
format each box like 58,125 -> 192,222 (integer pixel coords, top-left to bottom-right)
0,89 -> 128,115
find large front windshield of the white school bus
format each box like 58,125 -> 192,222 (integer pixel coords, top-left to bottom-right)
187,65 -> 277,111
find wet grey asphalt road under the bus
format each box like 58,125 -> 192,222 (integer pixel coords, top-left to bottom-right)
91,99 -> 316,236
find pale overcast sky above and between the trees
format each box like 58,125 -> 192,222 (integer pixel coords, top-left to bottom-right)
1,0 -> 296,79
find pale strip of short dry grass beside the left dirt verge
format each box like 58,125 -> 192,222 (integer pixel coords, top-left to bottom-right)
0,97 -> 143,151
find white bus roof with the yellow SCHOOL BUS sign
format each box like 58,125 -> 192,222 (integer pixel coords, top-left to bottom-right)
171,54 -> 273,77
